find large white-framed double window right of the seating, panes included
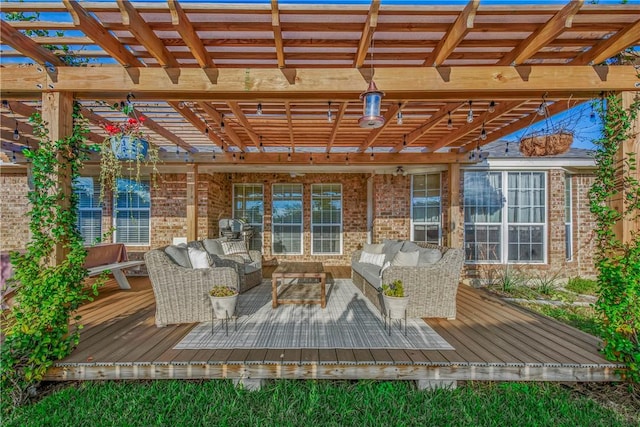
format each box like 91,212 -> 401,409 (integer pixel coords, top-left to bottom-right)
464,171 -> 546,263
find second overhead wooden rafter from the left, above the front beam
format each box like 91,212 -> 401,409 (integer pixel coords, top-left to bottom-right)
63,0 -> 143,67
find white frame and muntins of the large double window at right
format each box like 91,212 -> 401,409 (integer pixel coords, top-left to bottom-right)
463,169 -> 549,265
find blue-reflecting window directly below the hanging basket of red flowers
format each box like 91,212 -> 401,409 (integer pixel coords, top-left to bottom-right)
113,179 -> 151,245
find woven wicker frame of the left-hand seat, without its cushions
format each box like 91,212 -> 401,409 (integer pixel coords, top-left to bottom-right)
144,248 -> 238,328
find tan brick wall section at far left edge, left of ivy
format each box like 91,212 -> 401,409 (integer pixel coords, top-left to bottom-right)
0,170 -> 31,252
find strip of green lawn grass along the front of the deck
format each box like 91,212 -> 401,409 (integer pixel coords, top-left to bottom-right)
2,380 -> 632,427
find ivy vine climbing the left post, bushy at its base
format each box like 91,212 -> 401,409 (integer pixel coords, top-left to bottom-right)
0,105 -> 100,410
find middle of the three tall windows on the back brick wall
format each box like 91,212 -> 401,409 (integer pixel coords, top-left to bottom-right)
272,184 -> 302,255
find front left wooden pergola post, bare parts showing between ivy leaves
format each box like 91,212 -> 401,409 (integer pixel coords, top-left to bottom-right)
42,92 -> 73,264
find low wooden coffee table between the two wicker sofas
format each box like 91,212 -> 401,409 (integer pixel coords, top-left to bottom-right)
271,262 -> 327,308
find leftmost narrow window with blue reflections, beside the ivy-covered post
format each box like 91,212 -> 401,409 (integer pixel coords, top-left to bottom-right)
73,177 -> 102,245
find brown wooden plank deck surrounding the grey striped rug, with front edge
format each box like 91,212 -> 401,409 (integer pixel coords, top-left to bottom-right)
46,267 -> 620,384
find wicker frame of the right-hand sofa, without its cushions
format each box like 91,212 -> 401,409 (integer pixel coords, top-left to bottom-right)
351,241 -> 464,319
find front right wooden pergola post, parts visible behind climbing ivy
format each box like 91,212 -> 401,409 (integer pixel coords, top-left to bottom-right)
611,92 -> 640,243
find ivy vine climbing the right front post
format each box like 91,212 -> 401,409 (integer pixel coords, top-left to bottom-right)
589,94 -> 640,382
